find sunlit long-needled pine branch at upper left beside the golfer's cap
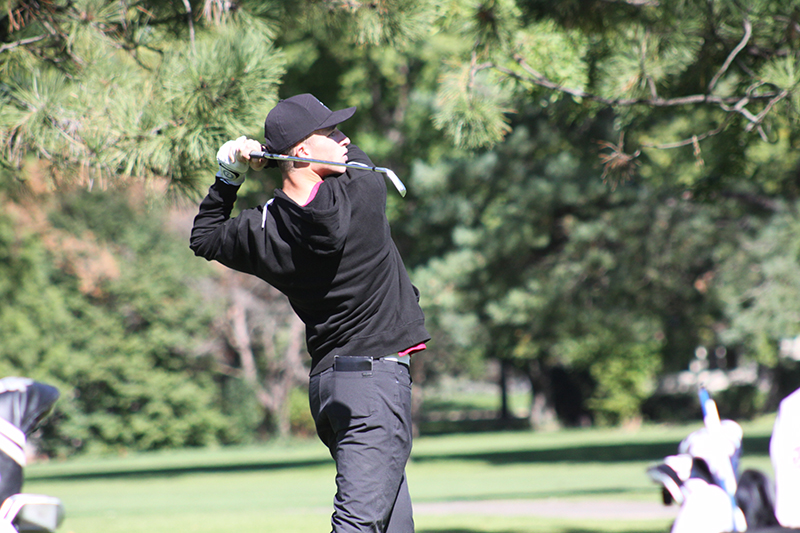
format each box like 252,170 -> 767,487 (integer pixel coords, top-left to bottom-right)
0,2 -> 283,191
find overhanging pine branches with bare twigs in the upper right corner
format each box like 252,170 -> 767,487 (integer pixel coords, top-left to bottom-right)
418,1 -> 798,191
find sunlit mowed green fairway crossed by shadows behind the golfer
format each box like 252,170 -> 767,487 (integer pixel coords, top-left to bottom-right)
25,417 -> 772,533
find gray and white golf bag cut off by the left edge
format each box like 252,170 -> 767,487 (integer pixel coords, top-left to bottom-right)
0,377 -> 64,533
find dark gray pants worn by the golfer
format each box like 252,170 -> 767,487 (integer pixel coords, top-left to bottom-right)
309,360 -> 414,533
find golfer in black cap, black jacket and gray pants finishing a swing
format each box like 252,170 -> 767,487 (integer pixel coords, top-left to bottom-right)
191,94 -> 430,533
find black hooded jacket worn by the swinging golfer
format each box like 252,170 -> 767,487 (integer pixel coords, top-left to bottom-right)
190,145 -> 430,374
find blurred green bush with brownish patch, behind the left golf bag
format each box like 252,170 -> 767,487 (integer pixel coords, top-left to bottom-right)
0,187 -> 226,454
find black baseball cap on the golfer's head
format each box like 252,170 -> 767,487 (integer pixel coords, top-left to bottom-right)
264,93 -> 356,154
